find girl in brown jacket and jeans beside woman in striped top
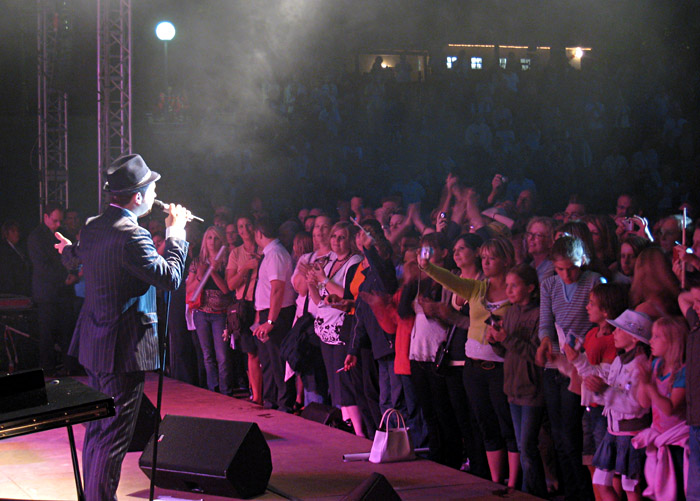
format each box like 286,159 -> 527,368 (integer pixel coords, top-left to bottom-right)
487,263 -> 547,497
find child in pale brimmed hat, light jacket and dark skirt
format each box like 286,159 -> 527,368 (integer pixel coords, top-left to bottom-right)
564,310 -> 651,501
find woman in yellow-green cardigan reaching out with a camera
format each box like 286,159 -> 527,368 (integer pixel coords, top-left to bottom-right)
418,238 -> 520,488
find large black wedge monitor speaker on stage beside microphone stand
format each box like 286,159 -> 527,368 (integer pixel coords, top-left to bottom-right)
139,414 -> 272,498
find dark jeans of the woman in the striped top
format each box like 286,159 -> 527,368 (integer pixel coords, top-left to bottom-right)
544,369 -> 594,500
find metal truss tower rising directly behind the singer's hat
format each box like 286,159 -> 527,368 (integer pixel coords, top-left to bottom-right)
97,0 -> 131,210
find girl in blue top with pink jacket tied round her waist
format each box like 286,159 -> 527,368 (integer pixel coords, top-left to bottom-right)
632,317 -> 688,500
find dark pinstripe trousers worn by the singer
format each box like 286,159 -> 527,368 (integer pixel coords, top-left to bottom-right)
83,370 -> 146,501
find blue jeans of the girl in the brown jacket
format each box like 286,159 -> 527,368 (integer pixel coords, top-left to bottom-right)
510,404 -> 547,497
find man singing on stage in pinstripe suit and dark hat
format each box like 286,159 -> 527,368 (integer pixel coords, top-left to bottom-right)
56,155 -> 190,501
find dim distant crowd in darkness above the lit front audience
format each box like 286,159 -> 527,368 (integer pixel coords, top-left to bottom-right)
163,51 -> 700,225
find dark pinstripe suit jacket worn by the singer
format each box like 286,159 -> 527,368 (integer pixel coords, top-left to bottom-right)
62,206 -> 188,373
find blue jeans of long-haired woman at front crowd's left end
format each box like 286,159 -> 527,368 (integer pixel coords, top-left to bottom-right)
194,310 -> 233,395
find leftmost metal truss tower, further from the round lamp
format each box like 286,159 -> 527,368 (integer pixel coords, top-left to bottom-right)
37,0 -> 71,217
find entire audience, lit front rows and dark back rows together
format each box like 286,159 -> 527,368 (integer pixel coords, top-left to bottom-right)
0,48 -> 700,500
